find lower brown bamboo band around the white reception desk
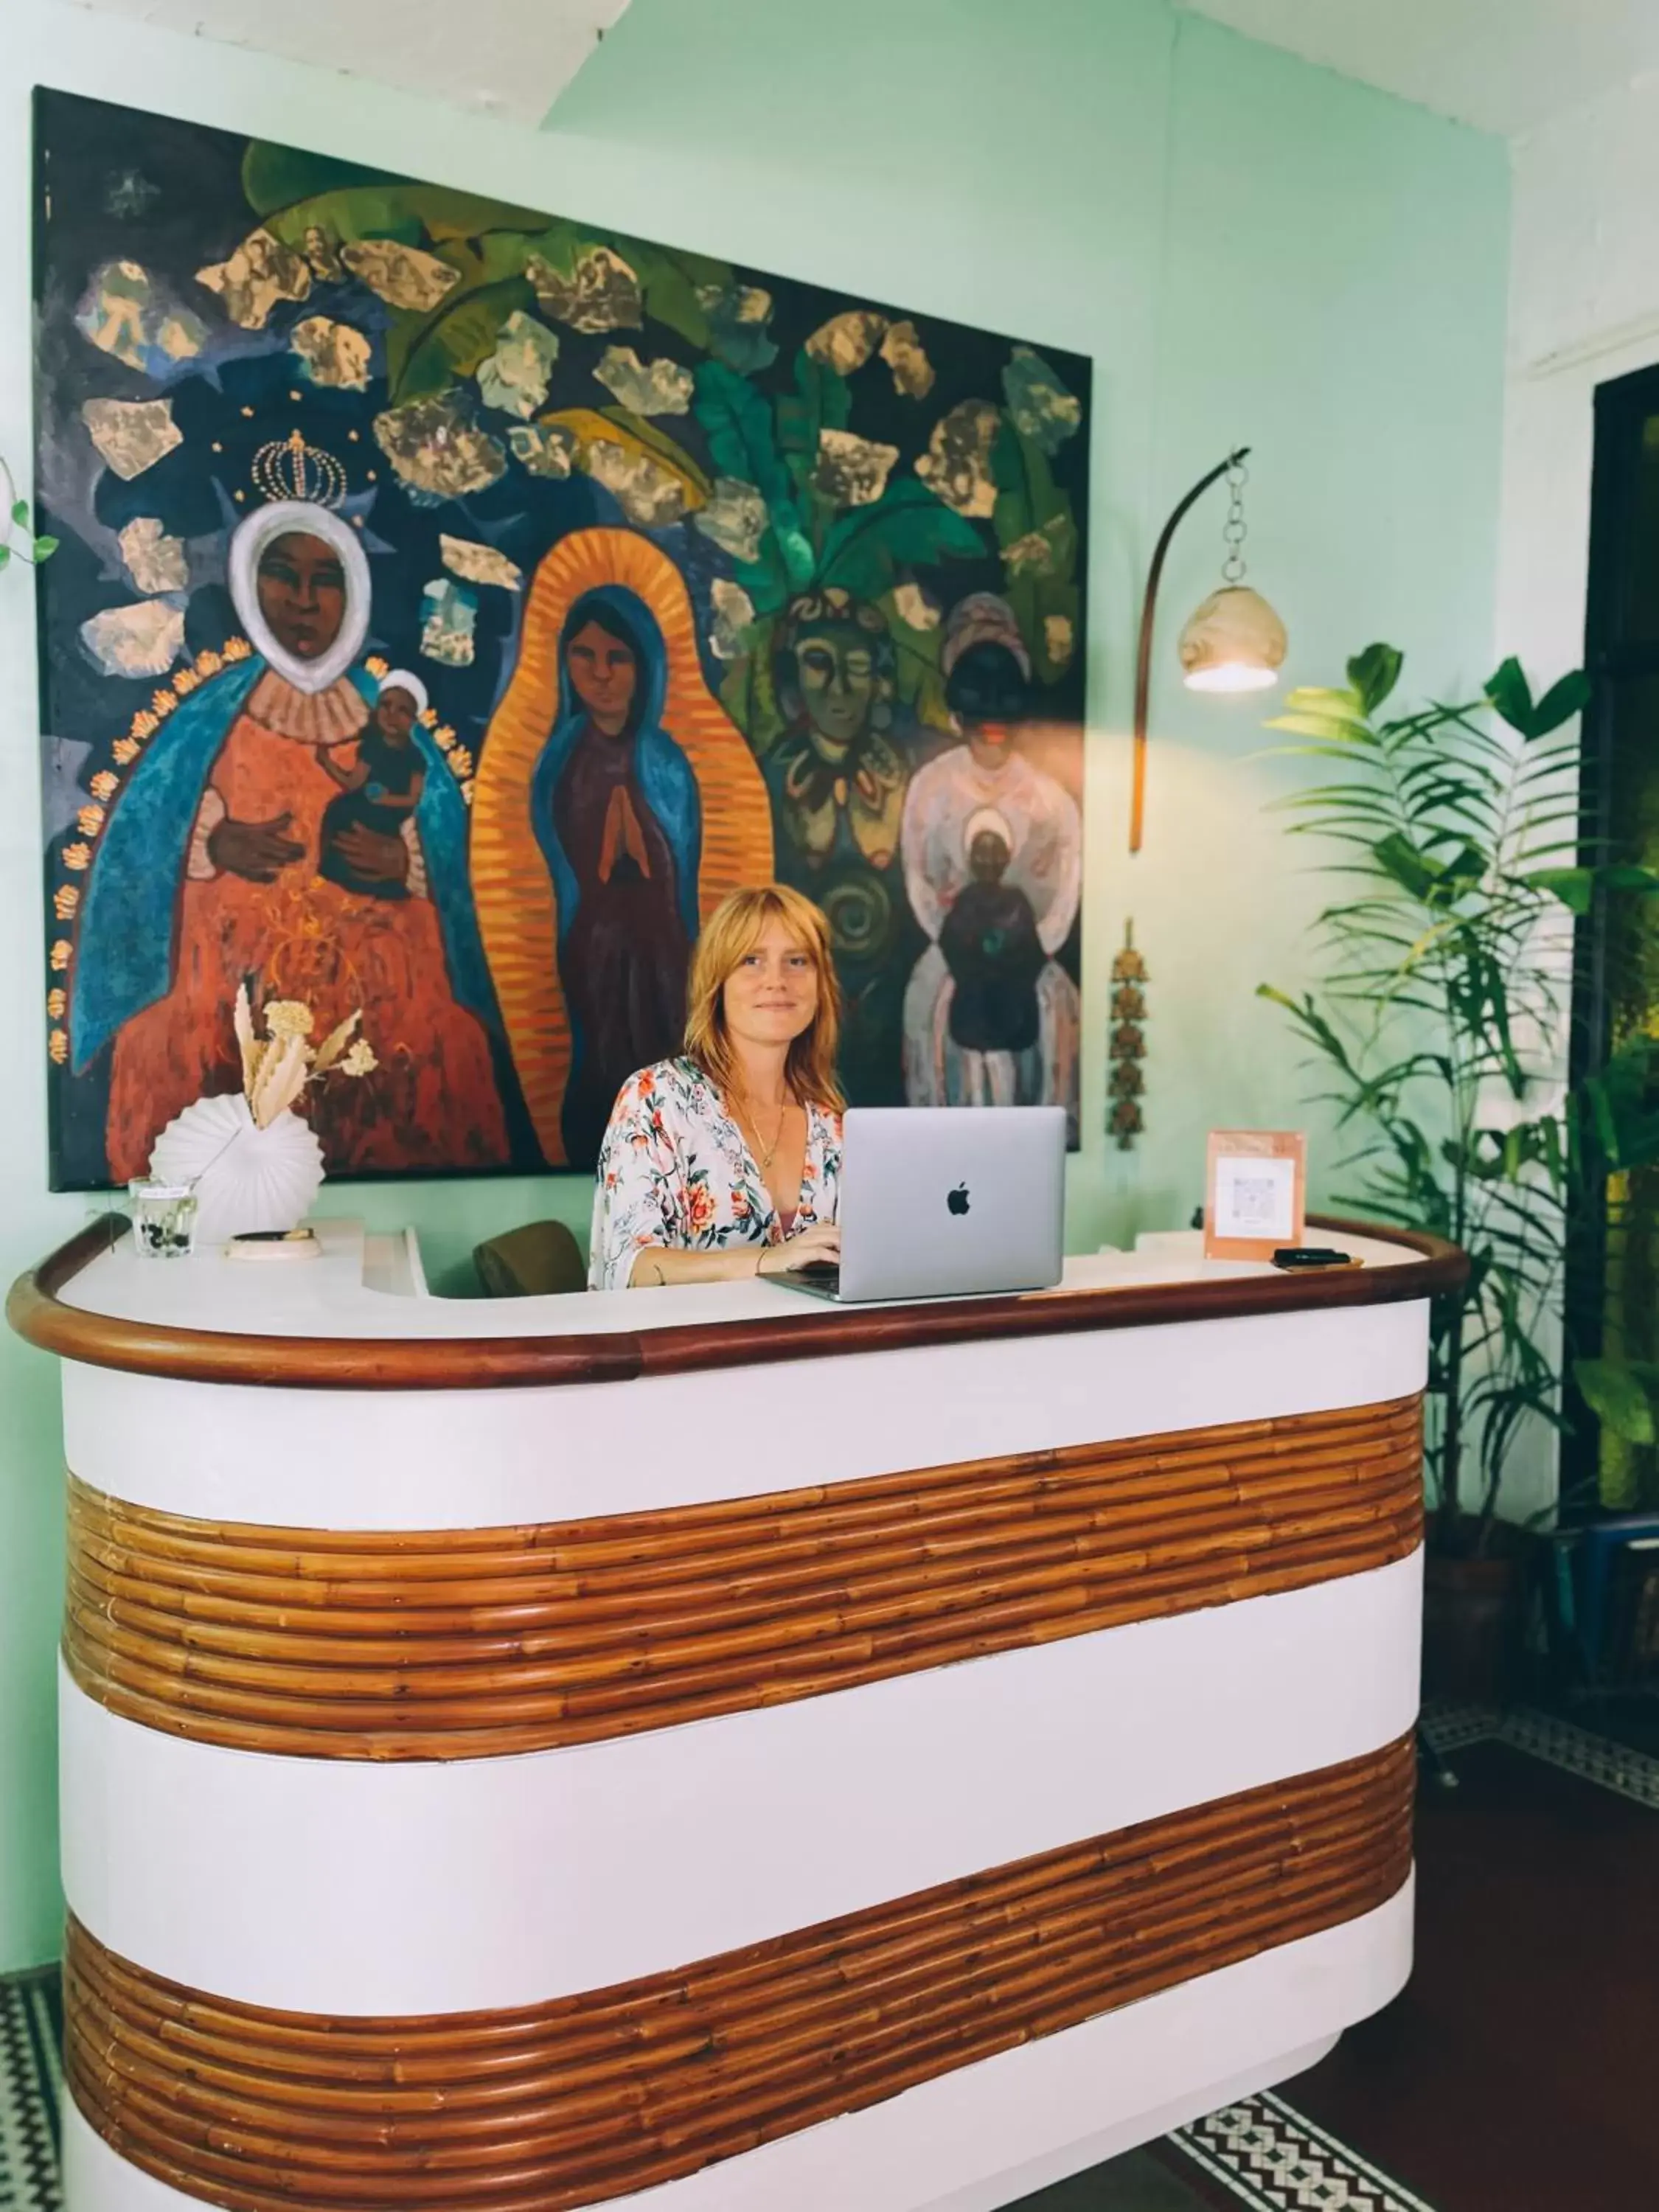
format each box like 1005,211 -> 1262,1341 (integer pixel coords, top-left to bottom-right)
64,1739 -> 1416,2212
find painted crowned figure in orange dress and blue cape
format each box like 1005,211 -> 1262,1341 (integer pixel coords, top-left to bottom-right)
69,467 -> 507,1179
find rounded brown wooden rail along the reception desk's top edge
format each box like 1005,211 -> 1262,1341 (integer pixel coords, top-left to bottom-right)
7,1214 -> 1469,1389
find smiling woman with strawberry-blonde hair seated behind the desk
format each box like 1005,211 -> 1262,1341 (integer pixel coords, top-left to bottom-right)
588,883 -> 843,1290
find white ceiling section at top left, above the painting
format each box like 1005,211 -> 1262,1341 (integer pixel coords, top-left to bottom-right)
68,0 -> 628,124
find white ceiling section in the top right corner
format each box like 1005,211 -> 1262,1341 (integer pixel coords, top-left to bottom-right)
1177,0 -> 1659,137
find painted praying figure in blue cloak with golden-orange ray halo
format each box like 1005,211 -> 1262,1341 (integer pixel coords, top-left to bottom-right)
471,529 -> 772,1168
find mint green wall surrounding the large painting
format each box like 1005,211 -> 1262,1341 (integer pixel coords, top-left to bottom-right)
0,0 -> 1506,1971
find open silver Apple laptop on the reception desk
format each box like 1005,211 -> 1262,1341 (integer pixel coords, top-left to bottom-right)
770,1106 -> 1066,1303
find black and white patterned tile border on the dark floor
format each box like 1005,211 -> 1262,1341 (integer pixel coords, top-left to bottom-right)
0,1705 -> 1659,2212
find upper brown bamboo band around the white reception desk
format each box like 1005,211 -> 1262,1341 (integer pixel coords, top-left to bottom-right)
64,1398 -> 1422,1759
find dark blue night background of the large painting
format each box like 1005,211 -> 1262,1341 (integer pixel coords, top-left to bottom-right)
35,93 -> 1091,1188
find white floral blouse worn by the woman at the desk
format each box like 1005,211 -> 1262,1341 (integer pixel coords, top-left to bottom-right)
588,1060 -> 841,1290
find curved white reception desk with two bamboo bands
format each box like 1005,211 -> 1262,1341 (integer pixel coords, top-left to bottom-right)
9,1223 -> 1462,2212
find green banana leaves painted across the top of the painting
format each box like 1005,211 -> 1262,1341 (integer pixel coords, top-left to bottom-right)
231,142 -> 1079,750
